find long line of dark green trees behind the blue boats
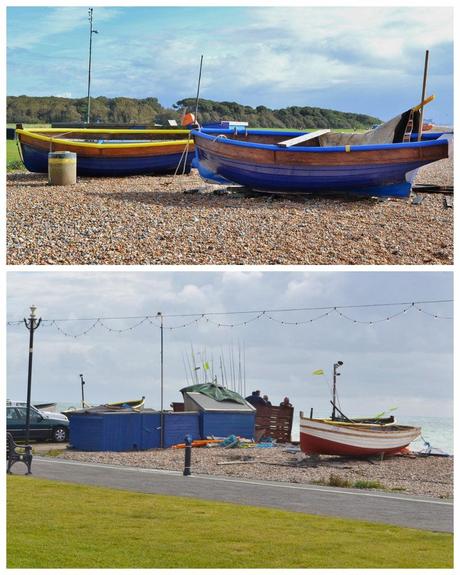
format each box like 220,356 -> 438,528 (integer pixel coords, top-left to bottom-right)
7,96 -> 380,129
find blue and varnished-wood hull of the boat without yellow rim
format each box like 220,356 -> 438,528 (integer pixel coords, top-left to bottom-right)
192,130 -> 448,197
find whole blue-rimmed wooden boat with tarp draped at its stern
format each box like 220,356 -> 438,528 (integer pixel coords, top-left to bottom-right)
192,100 -> 449,197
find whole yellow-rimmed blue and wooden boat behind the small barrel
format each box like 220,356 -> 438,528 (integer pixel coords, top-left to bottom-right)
16,128 -> 194,176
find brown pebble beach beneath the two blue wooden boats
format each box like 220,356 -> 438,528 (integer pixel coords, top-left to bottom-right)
7,158 -> 453,265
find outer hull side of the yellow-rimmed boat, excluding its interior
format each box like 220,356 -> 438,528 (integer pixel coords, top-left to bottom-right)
17,130 -> 194,177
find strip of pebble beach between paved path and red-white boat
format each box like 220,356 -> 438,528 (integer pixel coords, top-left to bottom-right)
54,445 -> 453,498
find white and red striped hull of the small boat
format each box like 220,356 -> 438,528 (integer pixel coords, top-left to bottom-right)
300,418 -> 421,457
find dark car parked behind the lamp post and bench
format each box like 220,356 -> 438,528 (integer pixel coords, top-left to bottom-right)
6,406 -> 69,443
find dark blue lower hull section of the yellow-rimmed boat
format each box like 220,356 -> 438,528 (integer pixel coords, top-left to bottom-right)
21,144 -> 193,177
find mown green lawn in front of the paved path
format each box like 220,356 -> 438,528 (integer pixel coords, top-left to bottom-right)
7,476 -> 453,569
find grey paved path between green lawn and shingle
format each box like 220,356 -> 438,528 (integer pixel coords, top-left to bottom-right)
17,456 -> 453,532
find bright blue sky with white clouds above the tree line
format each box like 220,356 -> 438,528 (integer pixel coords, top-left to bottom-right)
7,6 -> 453,123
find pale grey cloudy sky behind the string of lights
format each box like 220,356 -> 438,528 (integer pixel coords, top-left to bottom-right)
7,270 -> 453,424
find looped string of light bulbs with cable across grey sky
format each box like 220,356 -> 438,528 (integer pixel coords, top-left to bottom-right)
7,300 -> 453,338
